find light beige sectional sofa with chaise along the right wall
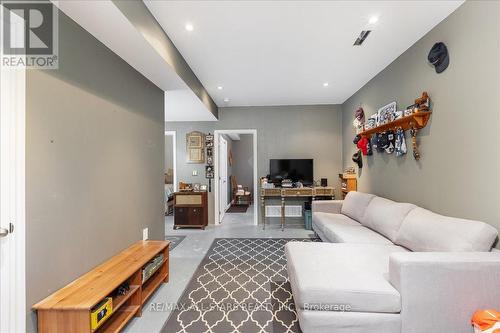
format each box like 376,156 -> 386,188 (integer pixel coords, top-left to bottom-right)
285,192 -> 500,333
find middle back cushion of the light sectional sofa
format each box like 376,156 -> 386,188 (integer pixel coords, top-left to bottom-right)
362,197 -> 417,241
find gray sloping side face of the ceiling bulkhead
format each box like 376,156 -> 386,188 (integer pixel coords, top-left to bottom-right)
113,0 -> 218,118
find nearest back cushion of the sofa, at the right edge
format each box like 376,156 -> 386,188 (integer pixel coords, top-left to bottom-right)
395,207 -> 498,252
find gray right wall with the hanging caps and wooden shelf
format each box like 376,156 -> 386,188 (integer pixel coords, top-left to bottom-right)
342,1 -> 500,246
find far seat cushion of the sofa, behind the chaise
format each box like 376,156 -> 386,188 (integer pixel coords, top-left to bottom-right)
322,224 -> 392,245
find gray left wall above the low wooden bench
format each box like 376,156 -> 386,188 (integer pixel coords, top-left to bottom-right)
26,12 -> 164,332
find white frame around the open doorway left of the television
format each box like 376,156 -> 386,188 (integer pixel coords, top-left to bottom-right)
214,129 -> 259,225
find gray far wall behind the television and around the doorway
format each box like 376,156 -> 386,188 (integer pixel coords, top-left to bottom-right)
166,105 -> 342,223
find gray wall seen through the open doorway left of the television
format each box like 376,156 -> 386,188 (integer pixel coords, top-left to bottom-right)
233,134 -> 253,189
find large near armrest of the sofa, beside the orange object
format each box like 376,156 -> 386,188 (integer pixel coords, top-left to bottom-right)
389,252 -> 500,333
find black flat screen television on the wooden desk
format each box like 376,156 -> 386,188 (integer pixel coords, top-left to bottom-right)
269,159 -> 314,186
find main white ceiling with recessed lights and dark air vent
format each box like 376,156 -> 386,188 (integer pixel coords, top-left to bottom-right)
144,0 -> 463,106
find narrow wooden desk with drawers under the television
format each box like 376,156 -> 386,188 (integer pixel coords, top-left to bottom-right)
260,187 -> 335,230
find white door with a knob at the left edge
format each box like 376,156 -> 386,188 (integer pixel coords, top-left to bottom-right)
0,23 -> 26,332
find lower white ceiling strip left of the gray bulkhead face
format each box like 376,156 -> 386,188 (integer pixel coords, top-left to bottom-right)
54,0 -> 217,121
